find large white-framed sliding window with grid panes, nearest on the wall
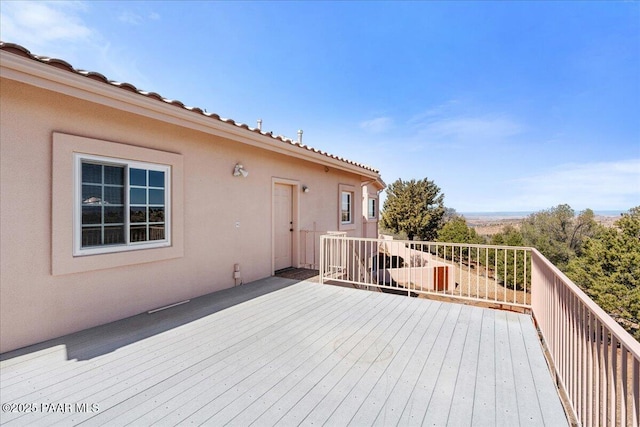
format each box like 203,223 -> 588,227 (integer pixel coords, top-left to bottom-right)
74,154 -> 171,255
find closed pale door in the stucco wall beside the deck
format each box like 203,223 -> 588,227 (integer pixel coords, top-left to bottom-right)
273,184 -> 293,270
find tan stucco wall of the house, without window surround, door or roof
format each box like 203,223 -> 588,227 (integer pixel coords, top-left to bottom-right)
0,79 -> 363,352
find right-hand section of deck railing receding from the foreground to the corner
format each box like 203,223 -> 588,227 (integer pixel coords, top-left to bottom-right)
531,249 -> 640,426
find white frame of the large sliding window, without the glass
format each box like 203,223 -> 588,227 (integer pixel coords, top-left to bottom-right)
73,153 -> 171,256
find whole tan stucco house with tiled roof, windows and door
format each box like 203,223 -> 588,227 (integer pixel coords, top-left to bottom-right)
0,43 -> 384,352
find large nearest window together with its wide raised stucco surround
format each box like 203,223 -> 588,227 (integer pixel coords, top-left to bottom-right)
51,132 -> 184,276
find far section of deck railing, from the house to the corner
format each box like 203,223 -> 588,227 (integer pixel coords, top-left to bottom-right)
320,236 -> 531,309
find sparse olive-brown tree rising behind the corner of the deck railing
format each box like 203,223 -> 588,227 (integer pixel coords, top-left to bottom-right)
520,205 -> 598,270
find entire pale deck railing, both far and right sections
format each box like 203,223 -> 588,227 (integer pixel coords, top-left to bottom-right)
319,235 -> 640,426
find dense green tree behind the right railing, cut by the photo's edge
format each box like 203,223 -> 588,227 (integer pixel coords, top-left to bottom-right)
566,206 -> 640,340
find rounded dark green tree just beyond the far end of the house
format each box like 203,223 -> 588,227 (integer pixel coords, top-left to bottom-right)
380,178 -> 445,240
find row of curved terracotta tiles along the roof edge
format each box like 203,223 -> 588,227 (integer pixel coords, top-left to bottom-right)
0,42 -> 379,173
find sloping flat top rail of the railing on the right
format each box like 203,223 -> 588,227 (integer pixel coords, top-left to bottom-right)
531,248 -> 640,360
